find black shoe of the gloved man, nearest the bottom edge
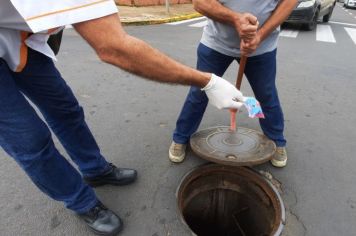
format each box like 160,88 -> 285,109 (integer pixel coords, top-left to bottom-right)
78,202 -> 123,236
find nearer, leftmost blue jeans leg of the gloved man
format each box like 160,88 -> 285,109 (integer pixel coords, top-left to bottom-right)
0,59 -> 98,213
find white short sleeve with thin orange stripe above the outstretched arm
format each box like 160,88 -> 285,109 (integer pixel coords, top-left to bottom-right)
10,0 -> 118,33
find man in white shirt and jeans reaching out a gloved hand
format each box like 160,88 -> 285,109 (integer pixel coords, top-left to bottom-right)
0,0 -> 256,235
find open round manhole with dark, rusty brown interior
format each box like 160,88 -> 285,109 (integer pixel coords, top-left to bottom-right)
177,164 -> 285,236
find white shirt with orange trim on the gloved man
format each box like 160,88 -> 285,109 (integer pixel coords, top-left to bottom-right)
0,0 -> 118,71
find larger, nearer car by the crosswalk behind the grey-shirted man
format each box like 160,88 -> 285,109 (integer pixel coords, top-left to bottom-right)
285,0 -> 336,30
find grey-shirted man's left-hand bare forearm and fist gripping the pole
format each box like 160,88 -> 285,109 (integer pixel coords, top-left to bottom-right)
193,0 -> 258,39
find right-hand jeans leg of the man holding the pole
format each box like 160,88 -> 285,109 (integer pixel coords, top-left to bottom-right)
245,49 -> 286,147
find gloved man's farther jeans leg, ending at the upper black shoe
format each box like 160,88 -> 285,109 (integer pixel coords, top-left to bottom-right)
14,50 -> 109,177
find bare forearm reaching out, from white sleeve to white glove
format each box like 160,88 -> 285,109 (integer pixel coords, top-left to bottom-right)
74,14 -> 211,87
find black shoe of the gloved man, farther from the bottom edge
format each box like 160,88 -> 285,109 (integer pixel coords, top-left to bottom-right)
84,163 -> 137,187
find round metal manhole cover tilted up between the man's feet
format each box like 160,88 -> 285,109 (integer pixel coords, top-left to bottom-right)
190,126 -> 276,166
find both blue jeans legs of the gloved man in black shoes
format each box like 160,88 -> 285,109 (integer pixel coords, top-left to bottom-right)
0,49 -> 109,213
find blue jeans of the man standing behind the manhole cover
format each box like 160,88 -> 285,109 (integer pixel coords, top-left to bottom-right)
173,44 -> 286,147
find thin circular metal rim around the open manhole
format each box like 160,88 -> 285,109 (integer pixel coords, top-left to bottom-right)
175,162 -> 286,236
